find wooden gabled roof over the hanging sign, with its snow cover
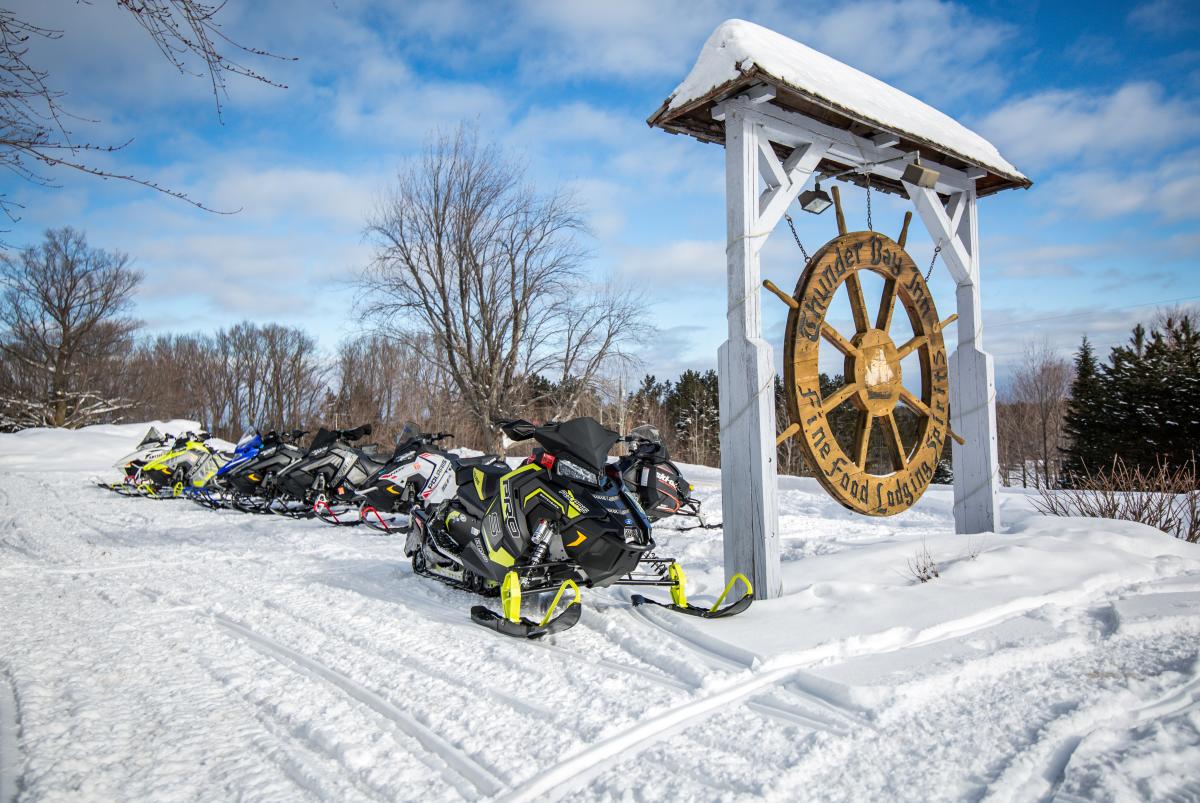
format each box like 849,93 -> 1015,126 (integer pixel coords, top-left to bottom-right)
648,19 -> 1032,194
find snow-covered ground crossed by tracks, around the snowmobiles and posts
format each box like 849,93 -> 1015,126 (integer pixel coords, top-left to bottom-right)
0,423 -> 1200,803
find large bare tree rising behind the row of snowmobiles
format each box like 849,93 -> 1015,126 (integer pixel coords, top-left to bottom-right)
362,127 -> 640,449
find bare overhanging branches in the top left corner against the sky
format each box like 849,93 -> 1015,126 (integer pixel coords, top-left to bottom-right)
0,0 -> 290,220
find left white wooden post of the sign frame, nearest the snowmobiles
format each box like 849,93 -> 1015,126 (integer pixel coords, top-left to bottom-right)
718,106 -> 782,599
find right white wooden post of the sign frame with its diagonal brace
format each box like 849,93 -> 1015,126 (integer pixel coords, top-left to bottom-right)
905,184 -> 1000,533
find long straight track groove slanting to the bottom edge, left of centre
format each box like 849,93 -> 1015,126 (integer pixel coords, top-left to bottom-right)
212,613 -> 505,799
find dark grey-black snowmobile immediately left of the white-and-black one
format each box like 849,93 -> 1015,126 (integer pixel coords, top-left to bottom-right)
271,424 -> 383,523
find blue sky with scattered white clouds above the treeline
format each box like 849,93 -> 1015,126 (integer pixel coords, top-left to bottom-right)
0,0 -> 1200,380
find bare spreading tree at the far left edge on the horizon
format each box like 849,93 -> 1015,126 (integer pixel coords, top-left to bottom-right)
0,227 -> 142,426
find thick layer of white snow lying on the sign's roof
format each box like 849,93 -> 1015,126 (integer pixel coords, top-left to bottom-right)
668,19 -> 1027,181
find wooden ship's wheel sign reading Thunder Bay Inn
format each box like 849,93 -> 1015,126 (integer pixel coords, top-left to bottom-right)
763,187 -> 962,516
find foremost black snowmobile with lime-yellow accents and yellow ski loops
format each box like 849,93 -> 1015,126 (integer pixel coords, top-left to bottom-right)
404,418 -> 754,639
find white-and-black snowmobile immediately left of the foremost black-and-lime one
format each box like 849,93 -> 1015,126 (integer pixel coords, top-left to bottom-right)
354,423 -> 506,533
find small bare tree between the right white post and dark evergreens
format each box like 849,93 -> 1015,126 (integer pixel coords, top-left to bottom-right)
1013,341 -> 1073,487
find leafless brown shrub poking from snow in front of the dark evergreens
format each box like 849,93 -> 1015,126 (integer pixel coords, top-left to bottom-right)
1033,457 -> 1200,544
